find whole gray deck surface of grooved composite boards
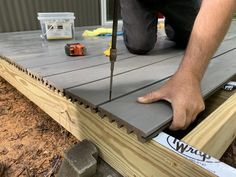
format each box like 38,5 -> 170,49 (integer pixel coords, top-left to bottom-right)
0,21 -> 236,141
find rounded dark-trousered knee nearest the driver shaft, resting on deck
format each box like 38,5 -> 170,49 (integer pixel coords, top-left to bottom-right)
124,34 -> 156,55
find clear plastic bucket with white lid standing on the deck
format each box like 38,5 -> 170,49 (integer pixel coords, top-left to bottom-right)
38,12 -> 75,40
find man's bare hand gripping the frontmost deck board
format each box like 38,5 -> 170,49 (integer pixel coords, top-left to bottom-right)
138,71 -> 205,130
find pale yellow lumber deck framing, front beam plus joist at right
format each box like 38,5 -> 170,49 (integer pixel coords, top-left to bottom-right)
0,54 -> 236,177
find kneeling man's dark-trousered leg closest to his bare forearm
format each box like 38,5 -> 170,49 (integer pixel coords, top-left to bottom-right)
162,0 -> 201,48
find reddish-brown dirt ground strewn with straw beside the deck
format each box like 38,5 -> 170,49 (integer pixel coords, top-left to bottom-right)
0,77 -> 236,177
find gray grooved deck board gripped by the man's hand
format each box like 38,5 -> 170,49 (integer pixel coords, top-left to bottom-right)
99,50 -> 236,139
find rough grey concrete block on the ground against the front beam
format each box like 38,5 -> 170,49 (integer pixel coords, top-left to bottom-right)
58,140 -> 98,177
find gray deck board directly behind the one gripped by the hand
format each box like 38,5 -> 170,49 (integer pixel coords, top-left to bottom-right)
65,37 -> 236,108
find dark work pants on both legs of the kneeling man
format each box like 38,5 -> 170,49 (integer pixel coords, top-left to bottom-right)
120,0 -> 201,54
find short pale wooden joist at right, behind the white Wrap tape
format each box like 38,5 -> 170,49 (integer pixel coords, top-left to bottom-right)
182,93 -> 236,159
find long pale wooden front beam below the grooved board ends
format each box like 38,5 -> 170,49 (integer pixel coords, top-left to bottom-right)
0,60 -> 213,177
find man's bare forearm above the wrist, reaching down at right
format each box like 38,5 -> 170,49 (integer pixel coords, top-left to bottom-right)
179,0 -> 236,81
